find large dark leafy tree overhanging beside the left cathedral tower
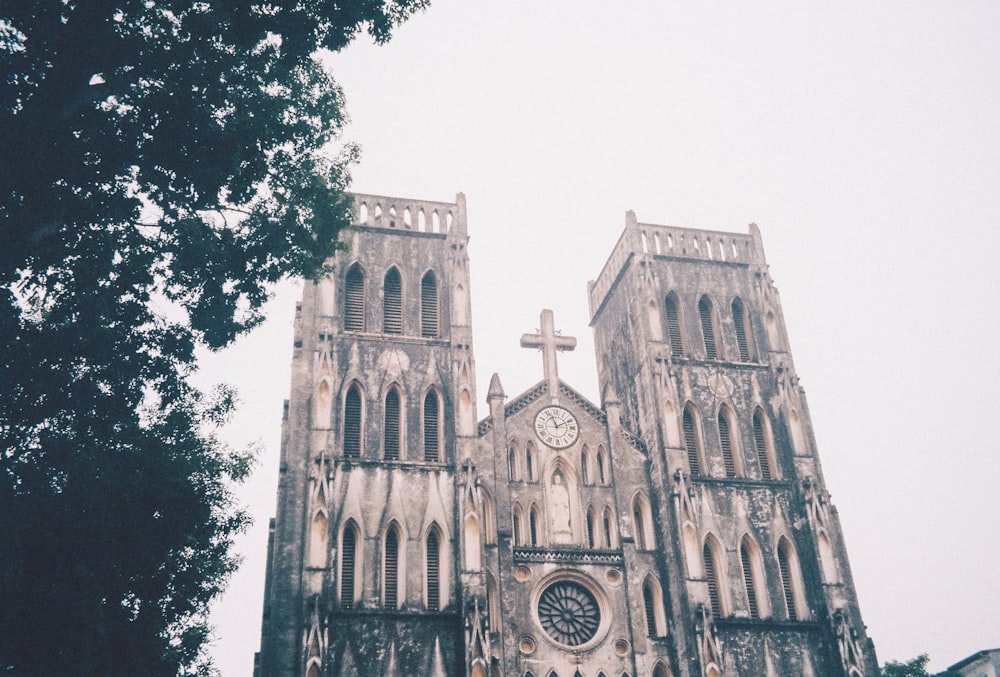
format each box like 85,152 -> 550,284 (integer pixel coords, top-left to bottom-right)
0,0 -> 426,675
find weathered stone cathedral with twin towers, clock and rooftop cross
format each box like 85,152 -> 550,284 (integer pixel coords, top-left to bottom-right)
255,194 -> 879,677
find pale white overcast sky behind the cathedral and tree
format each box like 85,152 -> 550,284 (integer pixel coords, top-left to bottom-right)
203,0 -> 1000,677
